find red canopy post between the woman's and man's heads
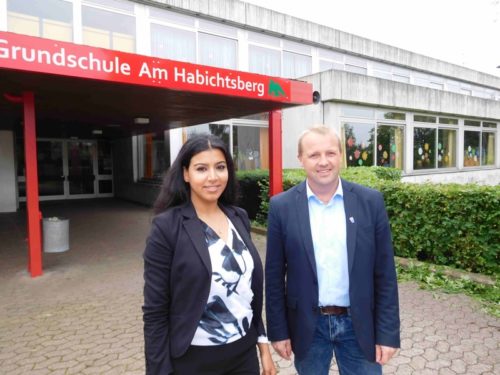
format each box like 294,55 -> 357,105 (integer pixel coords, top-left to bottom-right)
269,110 -> 283,197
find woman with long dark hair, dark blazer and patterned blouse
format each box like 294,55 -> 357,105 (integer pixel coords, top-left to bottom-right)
143,135 -> 276,375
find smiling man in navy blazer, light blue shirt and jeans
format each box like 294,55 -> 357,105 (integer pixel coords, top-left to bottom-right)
265,126 -> 400,375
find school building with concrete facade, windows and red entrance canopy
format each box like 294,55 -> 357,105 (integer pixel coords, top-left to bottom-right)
0,0 -> 500,273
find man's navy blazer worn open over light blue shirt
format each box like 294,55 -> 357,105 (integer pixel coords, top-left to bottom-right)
265,180 -> 400,361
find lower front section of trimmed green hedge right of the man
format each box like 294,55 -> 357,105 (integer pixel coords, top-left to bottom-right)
379,183 -> 500,274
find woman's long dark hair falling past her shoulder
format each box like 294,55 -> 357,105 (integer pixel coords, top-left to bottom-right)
153,134 -> 237,215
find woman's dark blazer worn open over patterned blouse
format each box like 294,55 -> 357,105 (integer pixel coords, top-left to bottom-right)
142,203 -> 265,375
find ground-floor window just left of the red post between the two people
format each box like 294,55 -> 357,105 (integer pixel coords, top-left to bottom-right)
233,125 -> 269,170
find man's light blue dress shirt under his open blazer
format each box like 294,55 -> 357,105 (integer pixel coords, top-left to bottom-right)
306,178 -> 350,306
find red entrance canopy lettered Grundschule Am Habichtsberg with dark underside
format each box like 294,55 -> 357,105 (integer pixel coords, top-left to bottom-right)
0,32 -> 312,138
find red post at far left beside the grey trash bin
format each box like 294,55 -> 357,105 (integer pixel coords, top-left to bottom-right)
23,92 -> 43,277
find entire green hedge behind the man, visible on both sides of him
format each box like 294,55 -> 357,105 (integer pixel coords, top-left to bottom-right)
238,167 -> 500,275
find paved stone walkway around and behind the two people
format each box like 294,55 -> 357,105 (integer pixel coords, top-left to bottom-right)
0,200 -> 500,375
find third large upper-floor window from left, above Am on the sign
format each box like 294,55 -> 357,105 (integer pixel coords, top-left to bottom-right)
151,23 -> 196,63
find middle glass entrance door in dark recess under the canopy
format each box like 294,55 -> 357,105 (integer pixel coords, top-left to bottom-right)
67,140 -> 96,197
